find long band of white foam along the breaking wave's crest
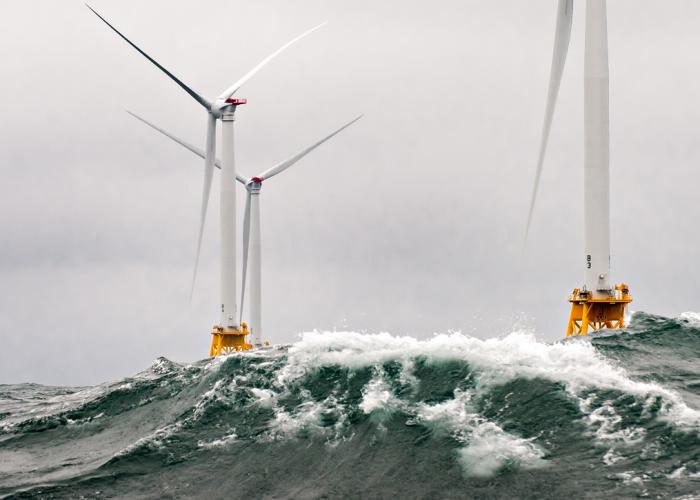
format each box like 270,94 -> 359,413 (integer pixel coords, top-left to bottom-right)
278,331 -> 700,430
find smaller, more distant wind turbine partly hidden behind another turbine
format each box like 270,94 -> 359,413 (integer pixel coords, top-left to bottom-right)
127,111 -> 362,347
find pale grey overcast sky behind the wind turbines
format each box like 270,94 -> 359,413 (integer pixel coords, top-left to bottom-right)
0,0 -> 700,384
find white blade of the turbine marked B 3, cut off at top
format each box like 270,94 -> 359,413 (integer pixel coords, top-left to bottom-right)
525,0 -> 574,240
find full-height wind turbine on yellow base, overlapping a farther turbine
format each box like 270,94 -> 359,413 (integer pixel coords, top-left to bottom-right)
86,4 -> 326,352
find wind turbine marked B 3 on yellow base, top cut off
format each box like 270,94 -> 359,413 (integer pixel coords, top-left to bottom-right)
525,0 -> 632,336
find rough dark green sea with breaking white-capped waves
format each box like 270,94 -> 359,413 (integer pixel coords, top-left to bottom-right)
0,313 -> 700,499
